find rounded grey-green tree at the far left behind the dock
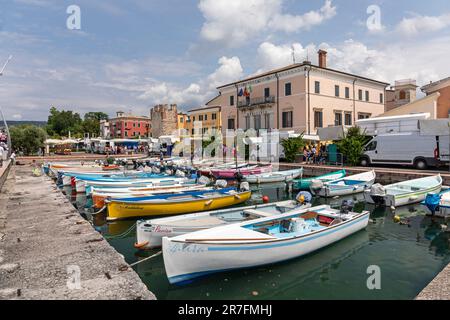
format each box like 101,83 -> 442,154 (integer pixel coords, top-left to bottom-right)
9,125 -> 47,155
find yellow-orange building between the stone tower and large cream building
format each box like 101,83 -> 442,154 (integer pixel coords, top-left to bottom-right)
186,106 -> 222,135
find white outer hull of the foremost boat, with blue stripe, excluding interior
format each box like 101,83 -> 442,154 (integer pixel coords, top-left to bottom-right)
162,212 -> 369,284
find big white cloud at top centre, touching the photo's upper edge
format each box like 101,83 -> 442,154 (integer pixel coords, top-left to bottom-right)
199,0 -> 336,46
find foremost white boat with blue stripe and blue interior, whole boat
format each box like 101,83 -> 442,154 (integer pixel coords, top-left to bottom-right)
162,205 -> 370,283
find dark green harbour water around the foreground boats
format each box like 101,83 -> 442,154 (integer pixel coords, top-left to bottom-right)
67,185 -> 450,300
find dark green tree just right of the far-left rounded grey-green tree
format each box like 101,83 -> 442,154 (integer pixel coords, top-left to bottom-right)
47,107 -> 83,137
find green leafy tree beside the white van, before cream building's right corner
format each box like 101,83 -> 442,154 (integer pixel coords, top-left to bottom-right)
336,127 -> 369,165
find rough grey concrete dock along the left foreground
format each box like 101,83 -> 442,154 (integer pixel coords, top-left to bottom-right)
0,166 -> 155,300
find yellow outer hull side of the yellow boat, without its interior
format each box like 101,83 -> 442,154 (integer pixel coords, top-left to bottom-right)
106,191 -> 251,220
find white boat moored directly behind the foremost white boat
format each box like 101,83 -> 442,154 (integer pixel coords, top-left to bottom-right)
135,200 -> 311,249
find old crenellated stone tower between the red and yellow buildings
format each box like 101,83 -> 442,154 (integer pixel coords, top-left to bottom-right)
150,104 -> 179,138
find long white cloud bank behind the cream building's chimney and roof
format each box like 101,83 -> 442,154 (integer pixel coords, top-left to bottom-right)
257,37 -> 450,85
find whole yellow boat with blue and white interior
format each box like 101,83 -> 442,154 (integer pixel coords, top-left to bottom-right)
106,188 -> 251,221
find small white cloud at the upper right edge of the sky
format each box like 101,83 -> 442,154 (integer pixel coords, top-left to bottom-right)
396,13 -> 450,36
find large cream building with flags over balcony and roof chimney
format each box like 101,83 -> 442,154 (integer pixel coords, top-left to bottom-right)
211,50 -> 389,134
